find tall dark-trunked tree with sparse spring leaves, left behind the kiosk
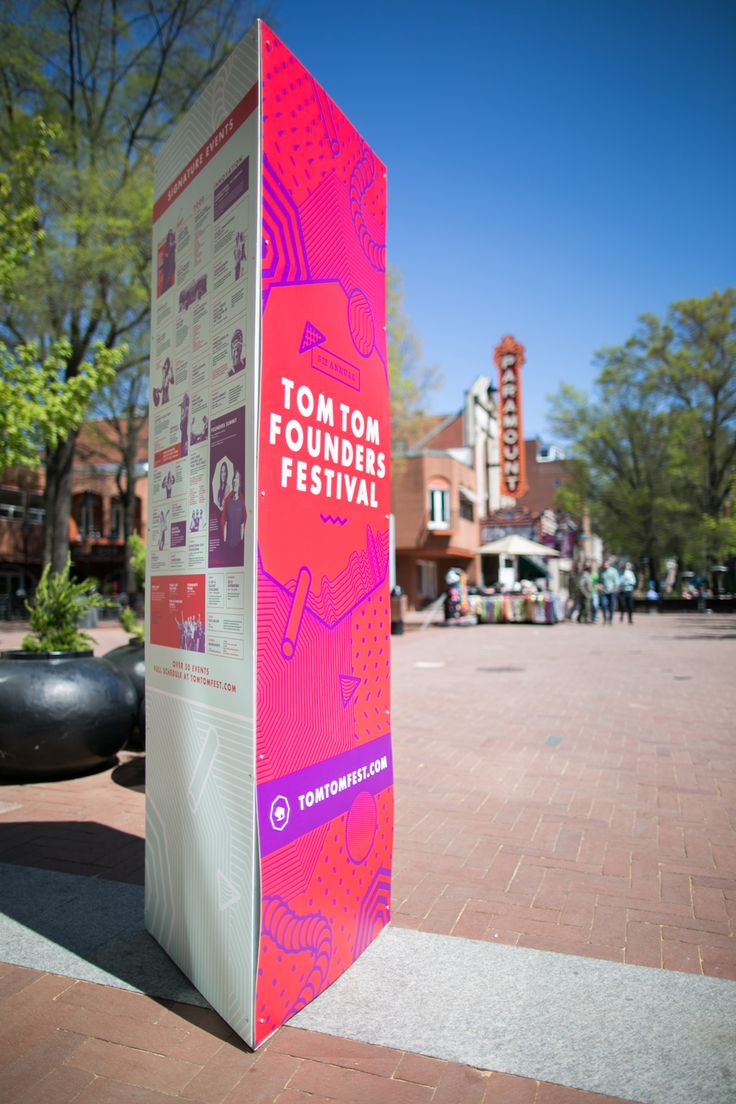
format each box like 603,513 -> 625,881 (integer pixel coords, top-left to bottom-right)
0,0 -> 264,571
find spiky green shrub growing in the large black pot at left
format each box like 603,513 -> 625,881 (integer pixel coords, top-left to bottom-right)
22,556 -> 114,651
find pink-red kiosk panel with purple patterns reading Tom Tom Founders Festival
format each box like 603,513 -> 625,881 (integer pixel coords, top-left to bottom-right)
253,26 -> 393,1043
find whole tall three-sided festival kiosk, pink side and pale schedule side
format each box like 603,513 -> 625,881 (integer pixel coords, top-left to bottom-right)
146,22 -> 393,1045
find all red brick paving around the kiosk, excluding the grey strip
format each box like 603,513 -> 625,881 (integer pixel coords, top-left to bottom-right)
0,614 -> 736,1104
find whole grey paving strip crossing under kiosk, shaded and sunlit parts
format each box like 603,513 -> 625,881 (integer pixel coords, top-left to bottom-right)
0,863 -> 736,1104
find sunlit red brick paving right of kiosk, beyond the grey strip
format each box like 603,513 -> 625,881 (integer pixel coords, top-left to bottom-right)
393,615 -> 736,979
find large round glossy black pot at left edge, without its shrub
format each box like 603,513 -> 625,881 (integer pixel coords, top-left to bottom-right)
0,651 -> 138,781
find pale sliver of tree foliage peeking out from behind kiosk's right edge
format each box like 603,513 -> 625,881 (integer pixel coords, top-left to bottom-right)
386,269 -> 440,455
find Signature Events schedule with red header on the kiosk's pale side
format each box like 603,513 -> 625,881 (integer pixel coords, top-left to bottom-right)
149,83 -> 255,662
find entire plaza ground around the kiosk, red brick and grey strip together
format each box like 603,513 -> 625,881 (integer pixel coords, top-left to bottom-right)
0,613 -> 736,1104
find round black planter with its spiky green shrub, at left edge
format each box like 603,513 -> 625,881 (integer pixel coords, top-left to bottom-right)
0,559 -> 137,779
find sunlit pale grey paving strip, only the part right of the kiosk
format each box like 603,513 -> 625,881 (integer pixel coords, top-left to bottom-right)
290,927 -> 736,1104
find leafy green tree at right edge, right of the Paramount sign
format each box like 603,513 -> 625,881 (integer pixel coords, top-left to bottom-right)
551,289 -> 736,573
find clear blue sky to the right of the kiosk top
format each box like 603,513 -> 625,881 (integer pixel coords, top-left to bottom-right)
269,0 -> 736,439
